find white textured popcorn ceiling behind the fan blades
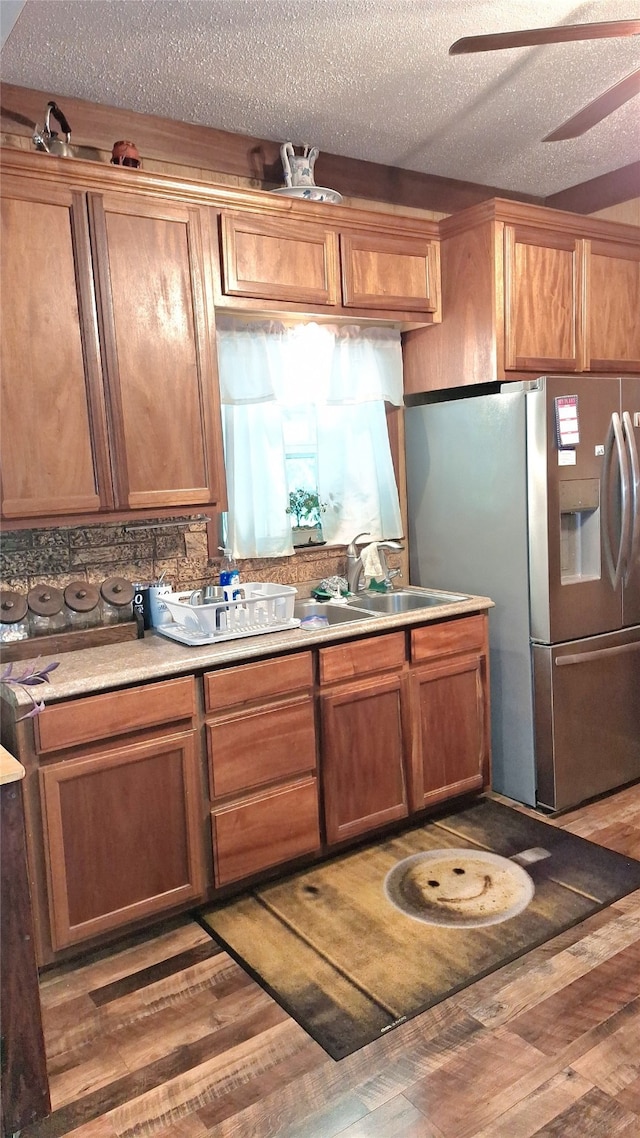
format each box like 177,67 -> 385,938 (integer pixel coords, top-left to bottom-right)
0,0 -> 640,197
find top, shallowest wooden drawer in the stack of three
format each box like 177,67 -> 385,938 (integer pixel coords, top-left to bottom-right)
205,652 -> 313,711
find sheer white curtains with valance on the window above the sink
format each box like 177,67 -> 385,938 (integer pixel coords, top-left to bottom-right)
218,318 -> 402,558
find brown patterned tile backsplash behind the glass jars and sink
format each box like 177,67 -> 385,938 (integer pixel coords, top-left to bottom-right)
0,518 -> 345,593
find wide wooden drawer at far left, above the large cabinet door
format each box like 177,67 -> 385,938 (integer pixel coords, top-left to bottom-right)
35,676 -> 196,754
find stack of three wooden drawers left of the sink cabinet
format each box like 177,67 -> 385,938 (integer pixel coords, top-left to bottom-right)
205,652 -> 320,887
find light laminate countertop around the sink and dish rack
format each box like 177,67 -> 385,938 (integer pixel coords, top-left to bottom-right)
3,595 -> 493,708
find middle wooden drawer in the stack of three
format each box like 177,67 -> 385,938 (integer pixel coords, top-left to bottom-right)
207,698 -> 315,798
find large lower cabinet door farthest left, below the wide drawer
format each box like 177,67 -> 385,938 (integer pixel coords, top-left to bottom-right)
40,732 -> 204,949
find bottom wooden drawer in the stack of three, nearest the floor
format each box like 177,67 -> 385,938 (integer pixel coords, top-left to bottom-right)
212,778 -> 320,885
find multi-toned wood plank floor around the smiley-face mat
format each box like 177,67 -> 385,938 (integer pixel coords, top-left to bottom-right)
22,785 -> 640,1138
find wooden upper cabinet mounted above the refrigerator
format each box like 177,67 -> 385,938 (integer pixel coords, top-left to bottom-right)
403,199 -> 640,395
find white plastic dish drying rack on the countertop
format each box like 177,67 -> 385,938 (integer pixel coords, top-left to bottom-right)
156,582 -> 300,646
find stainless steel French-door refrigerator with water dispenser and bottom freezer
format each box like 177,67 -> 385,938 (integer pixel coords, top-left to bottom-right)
405,376 -> 640,810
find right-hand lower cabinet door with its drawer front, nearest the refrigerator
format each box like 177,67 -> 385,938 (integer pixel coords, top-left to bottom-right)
410,616 -> 490,810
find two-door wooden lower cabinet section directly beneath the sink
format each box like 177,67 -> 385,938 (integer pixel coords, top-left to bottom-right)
319,616 -> 490,844
